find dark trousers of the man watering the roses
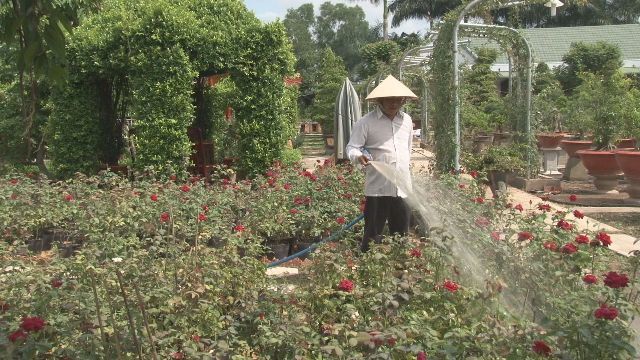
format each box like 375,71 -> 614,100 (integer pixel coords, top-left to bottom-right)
360,196 -> 410,252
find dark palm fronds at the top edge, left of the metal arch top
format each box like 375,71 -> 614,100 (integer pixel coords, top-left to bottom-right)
389,0 -> 462,29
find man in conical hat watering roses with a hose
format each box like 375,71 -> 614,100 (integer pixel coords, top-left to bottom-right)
347,75 -> 417,252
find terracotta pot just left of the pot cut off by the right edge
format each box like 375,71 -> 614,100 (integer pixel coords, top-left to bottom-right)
576,150 -> 622,192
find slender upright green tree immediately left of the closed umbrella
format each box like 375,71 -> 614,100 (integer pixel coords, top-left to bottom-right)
310,48 -> 347,133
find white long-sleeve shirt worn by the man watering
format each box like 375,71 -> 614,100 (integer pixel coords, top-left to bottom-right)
347,107 -> 413,198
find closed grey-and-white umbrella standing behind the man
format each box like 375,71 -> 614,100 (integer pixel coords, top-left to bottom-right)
333,78 -> 361,160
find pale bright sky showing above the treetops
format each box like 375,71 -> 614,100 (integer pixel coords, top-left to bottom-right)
244,0 -> 427,35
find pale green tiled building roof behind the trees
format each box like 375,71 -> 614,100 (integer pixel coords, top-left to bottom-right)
469,24 -> 640,73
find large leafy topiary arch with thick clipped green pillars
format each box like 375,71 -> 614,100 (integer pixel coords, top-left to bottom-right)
48,0 -> 297,176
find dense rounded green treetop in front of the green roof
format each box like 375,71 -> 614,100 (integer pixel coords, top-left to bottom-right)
556,41 -> 622,95
